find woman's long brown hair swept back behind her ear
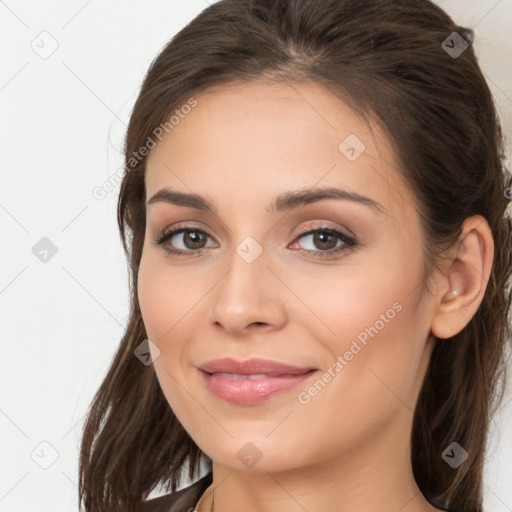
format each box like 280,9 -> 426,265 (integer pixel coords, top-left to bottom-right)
79,0 -> 512,512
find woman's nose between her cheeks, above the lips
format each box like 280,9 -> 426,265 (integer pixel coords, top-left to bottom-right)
210,244 -> 290,336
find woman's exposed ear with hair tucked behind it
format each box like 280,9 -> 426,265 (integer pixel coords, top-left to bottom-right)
431,215 -> 494,339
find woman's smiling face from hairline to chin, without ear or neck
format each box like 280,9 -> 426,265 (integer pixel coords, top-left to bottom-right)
138,83 -> 434,471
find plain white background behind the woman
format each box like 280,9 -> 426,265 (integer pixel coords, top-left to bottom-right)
0,0 -> 512,512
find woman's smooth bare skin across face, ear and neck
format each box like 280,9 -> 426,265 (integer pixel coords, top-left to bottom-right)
138,81 -> 494,512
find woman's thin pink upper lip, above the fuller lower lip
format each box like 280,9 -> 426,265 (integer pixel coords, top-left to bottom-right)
198,357 -> 316,375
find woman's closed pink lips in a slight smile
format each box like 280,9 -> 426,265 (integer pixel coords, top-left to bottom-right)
199,358 -> 317,405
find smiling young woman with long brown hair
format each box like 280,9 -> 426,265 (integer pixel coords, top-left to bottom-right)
79,0 -> 511,512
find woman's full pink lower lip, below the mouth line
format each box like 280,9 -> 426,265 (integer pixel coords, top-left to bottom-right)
200,370 -> 317,405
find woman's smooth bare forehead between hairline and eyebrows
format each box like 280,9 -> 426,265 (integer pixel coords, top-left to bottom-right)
146,82 -> 414,221
